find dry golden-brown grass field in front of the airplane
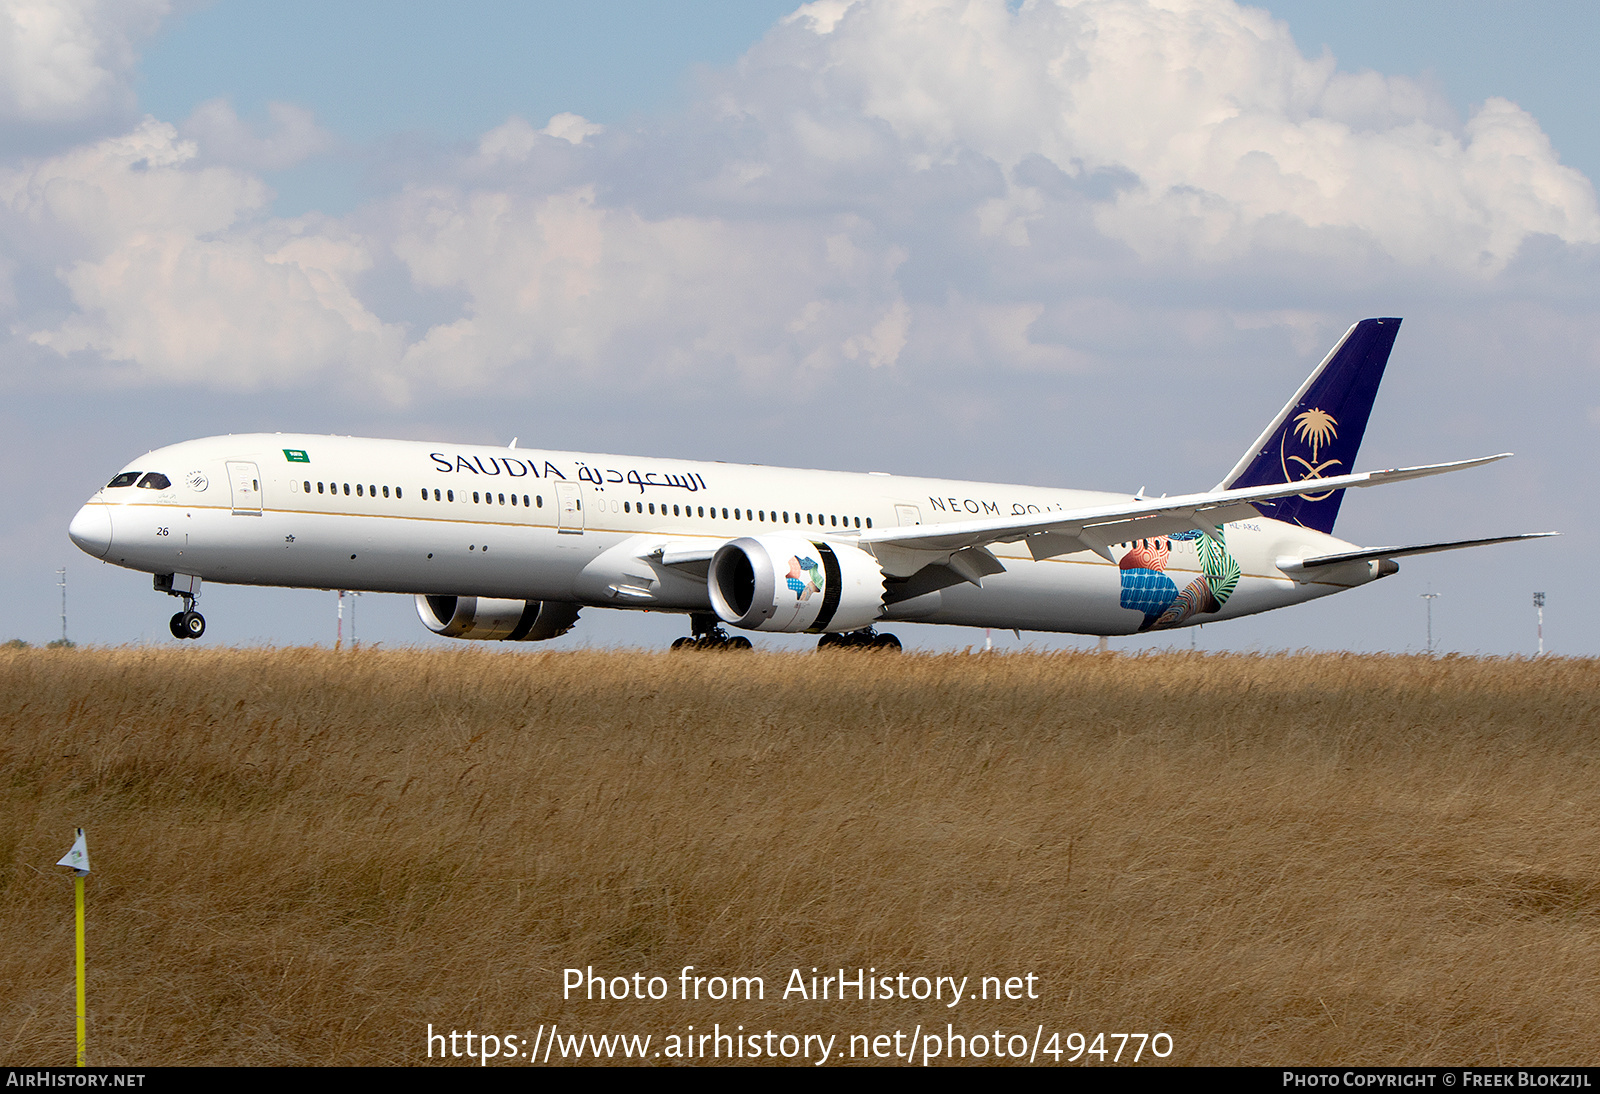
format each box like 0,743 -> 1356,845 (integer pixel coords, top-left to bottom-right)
0,648 -> 1600,1065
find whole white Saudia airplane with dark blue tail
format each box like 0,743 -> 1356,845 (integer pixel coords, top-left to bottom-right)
69,318 -> 1557,649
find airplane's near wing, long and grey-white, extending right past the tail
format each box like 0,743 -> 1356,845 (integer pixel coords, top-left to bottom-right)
858,453 -> 1510,572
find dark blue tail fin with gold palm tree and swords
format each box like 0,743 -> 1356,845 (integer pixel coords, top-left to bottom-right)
1218,318 -> 1400,533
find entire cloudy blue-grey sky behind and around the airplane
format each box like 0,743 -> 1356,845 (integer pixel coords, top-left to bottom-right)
0,0 -> 1600,654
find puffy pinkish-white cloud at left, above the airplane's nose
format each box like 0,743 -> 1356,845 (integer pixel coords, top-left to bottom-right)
0,120 -> 400,389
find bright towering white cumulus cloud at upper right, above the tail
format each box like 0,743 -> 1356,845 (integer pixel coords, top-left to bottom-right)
768,0 -> 1600,272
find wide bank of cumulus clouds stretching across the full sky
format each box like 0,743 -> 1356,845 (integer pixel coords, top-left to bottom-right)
0,0 -> 1600,397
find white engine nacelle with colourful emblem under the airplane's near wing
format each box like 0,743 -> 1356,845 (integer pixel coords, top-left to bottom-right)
709,536 -> 883,633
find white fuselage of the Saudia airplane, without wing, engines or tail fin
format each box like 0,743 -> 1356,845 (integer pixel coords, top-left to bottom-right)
72,433 -> 1376,635
